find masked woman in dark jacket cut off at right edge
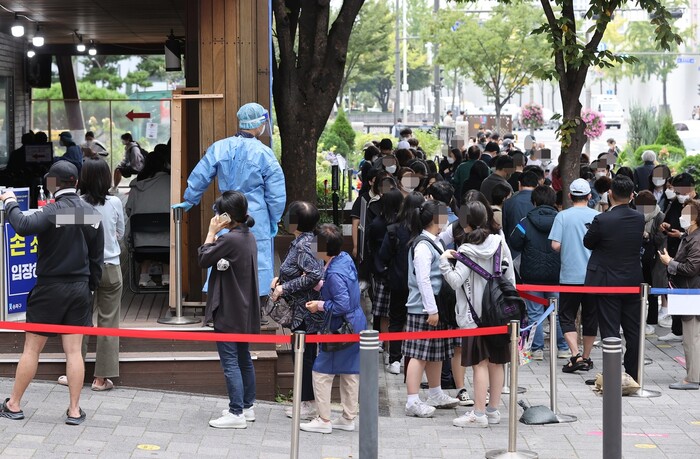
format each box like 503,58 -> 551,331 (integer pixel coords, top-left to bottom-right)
659,200 -> 700,390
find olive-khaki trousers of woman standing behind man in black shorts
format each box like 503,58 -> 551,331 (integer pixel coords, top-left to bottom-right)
83,264 -> 122,378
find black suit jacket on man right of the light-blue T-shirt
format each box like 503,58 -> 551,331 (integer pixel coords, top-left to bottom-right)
584,205 -> 644,287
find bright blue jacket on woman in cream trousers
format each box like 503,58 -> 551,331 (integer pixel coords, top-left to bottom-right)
314,252 -> 367,375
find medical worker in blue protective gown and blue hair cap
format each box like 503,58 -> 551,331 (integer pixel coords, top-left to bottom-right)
173,103 -> 287,296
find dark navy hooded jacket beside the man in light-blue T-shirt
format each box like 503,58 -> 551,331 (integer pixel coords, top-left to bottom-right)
508,206 -> 561,285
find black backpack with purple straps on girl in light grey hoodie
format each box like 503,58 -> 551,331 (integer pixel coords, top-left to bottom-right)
455,243 -> 526,327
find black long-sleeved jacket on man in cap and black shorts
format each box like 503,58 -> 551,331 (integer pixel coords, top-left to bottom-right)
5,190 -> 105,291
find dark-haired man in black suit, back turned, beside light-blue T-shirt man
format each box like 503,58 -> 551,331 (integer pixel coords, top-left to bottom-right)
583,175 -> 644,380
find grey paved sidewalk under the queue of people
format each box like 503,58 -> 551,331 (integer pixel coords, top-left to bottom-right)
0,329 -> 700,459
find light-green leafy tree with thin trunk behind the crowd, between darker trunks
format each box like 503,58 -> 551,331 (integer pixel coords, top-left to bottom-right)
427,1 -> 550,130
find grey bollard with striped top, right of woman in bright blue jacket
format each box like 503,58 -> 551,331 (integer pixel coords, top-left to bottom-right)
359,330 -> 379,459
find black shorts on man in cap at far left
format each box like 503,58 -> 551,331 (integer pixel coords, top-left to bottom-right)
26,282 -> 92,336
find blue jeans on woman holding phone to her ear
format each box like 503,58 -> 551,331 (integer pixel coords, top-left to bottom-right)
216,342 -> 255,414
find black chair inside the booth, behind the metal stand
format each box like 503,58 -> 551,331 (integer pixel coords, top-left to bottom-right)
127,213 -> 170,293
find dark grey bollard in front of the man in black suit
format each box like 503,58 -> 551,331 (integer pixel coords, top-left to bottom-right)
603,338 -> 622,459
